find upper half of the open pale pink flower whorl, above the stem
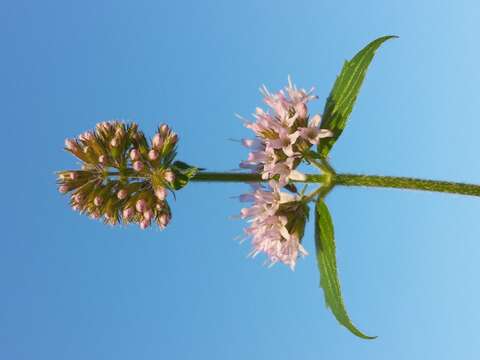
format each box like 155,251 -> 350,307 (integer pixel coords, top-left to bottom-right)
240,78 -> 332,187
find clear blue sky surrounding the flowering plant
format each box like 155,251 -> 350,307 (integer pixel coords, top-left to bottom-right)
0,0 -> 480,360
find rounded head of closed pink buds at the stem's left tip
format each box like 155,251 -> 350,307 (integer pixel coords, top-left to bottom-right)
58,121 -> 181,229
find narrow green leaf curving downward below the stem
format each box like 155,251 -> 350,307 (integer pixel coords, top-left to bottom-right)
315,198 -> 376,339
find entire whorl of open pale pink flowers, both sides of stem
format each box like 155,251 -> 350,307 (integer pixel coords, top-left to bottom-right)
240,78 -> 332,269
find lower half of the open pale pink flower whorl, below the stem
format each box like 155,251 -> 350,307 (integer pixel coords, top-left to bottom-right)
240,186 -> 308,270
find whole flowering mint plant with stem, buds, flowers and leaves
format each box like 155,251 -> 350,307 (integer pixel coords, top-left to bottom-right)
57,36 -> 480,339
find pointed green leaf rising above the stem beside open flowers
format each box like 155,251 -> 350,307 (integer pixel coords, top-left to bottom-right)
317,36 -> 397,157
